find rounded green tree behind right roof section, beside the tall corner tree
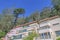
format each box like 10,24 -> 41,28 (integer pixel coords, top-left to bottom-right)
40,7 -> 51,19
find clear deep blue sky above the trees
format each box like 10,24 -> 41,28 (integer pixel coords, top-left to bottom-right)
0,0 -> 51,16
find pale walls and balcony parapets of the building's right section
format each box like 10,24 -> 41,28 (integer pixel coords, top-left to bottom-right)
39,18 -> 60,40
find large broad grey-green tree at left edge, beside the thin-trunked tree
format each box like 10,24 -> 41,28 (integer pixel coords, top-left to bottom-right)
0,10 -> 14,33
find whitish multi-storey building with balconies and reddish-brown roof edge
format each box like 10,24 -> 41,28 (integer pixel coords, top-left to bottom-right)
5,16 -> 60,40
